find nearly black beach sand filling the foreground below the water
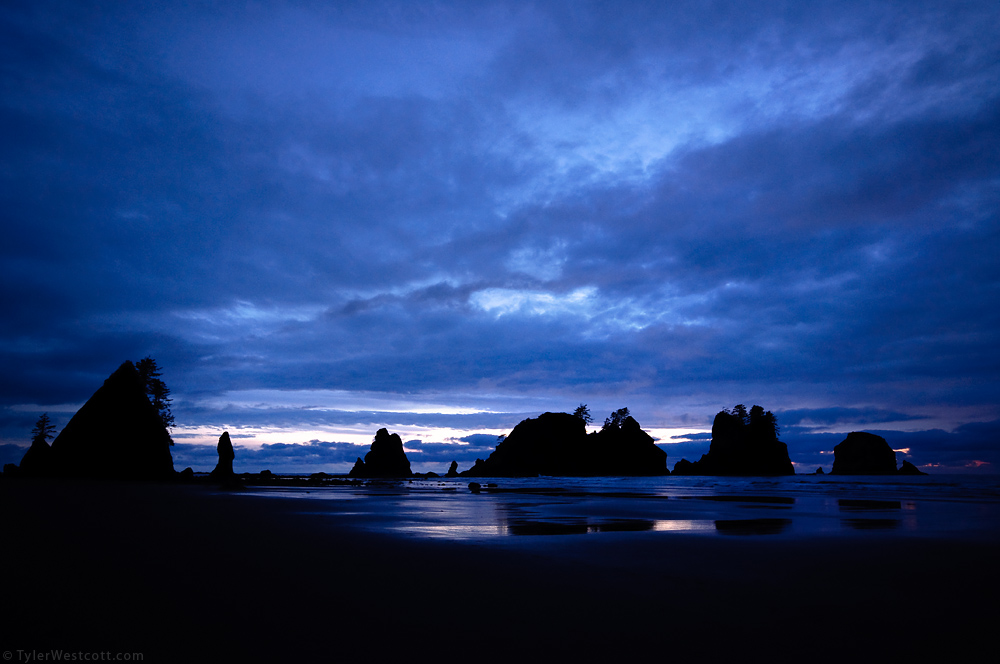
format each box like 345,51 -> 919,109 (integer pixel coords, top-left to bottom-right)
0,480 -> 1000,662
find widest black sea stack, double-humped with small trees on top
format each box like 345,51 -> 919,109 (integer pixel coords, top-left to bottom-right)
461,413 -> 670,477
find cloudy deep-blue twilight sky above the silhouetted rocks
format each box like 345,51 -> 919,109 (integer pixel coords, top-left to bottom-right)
0,0 -> 1000,473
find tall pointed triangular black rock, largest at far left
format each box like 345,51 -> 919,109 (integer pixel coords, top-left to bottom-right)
48,362 -> 174,480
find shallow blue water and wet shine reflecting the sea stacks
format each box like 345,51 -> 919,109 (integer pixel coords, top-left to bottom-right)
246,475 -> 1000,542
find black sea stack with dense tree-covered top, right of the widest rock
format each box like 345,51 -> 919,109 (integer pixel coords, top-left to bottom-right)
674,404 -> 795,475
